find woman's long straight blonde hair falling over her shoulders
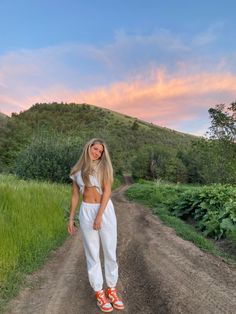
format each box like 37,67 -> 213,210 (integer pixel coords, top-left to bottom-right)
70,138 -> 113,187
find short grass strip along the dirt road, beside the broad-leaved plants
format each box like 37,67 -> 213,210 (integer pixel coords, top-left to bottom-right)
126,181 -> 236,265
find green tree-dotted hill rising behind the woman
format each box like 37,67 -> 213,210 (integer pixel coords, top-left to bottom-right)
0,103 -> 197,178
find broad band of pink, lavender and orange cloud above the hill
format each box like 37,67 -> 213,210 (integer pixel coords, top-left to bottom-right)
0,27 -> 236,133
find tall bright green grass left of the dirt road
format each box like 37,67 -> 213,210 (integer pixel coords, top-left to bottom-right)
0,175 -> 70,310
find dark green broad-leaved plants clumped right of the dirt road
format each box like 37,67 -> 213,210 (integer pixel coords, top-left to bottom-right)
169,184 -> 236,239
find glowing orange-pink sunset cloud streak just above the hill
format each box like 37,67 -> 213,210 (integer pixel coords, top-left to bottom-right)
0,70 -> 236,134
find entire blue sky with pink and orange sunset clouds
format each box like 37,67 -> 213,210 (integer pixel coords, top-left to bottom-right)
0,0 -> 236,135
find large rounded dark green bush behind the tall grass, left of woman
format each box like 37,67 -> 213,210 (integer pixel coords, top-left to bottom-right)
14,137 -> 83,183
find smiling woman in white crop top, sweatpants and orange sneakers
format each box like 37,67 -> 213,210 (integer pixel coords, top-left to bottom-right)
68,139 -> 124,312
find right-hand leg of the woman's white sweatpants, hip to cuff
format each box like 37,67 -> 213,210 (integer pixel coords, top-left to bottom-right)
99,200 -> 118,288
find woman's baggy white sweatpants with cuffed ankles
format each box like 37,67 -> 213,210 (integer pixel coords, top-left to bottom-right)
79,200 -> 118,291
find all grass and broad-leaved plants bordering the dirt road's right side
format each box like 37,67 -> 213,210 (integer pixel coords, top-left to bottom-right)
126,180 -> 236,262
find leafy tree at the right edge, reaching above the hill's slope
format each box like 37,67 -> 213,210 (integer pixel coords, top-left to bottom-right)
183,102 -> 236,184
